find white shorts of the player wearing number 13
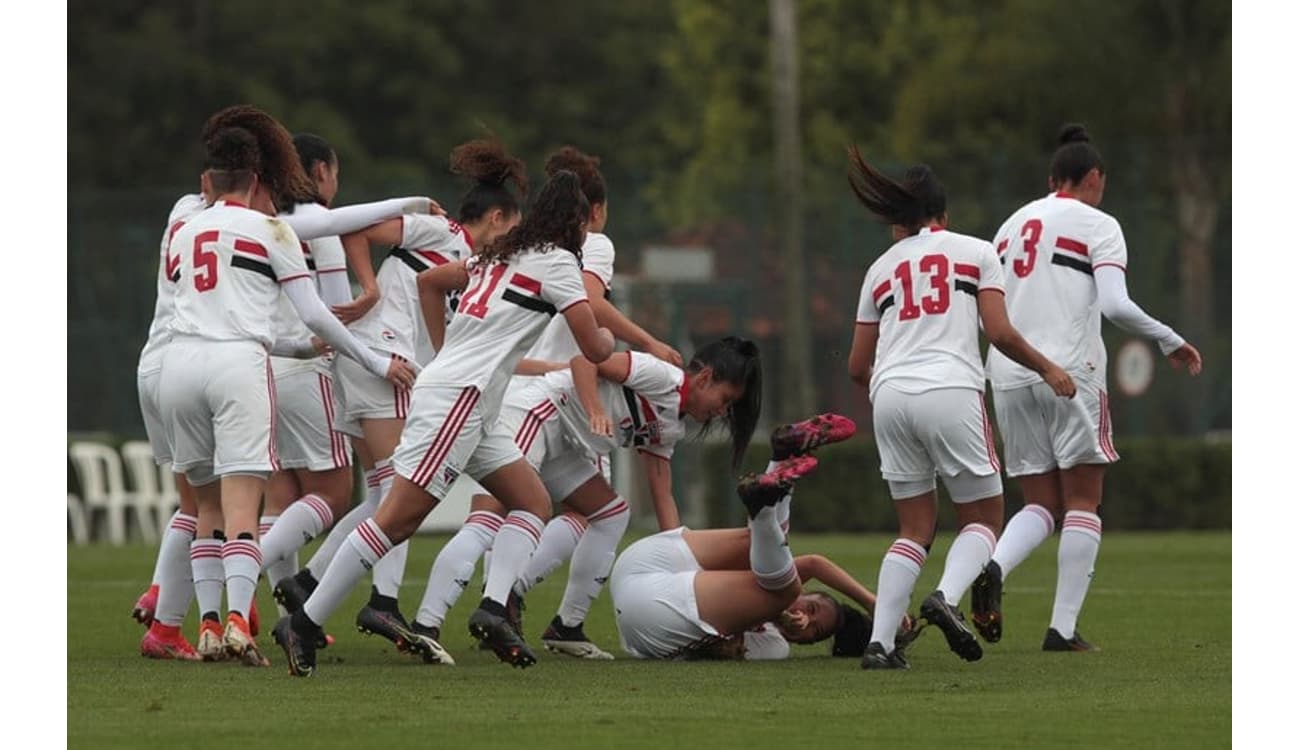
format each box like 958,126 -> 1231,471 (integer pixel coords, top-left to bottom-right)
871,383 -> 1002,503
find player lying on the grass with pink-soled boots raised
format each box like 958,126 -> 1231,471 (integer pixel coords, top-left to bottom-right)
610,415 -> 910,660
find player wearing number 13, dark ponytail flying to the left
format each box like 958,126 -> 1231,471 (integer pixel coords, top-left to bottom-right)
849,148 -> 1075,669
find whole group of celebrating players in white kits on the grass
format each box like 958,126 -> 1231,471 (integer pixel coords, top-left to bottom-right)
134,105 -> 1200,676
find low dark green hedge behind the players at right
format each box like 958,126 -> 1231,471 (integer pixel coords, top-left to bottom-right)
699,438 -> 1232,532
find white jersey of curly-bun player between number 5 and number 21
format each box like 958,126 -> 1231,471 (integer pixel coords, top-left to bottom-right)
350,214 -> 473,367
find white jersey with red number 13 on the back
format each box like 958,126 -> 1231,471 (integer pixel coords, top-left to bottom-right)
858,227 -> 1002,399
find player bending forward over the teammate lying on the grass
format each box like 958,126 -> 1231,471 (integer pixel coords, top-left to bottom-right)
415,337 -> 763,659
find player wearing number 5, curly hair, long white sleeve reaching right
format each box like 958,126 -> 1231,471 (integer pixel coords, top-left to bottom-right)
159,110 -> 415,666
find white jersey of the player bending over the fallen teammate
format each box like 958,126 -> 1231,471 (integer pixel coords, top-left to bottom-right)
541,351 -> 686,459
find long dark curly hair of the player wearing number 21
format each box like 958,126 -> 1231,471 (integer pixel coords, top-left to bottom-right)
477,169 -> 592,263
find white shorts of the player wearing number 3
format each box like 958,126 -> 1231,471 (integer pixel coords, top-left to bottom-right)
993,380 -> 1119,477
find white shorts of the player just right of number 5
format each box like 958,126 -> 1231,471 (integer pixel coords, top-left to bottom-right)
270,357 -> 352,472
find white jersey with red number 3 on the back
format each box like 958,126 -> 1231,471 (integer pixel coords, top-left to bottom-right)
988,192 -> 1128,390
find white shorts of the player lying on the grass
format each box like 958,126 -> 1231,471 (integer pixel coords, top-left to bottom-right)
610,526 -> 719,659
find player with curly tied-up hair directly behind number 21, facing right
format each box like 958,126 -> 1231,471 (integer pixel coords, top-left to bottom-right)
276,139 -> 528,650
